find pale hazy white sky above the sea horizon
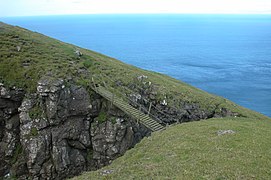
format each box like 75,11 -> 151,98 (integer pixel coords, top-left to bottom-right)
0,0 -> 271,17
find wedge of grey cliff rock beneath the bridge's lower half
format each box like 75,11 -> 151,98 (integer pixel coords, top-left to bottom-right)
91,118 -> 150,168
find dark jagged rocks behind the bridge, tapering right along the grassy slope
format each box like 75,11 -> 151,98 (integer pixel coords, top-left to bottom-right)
126,75 -> 239,124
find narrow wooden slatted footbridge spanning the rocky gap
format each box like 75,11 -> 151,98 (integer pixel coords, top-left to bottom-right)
91,81 -> 165,131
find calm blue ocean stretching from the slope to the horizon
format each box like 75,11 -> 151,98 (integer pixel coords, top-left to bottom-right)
0,15 -> 271,117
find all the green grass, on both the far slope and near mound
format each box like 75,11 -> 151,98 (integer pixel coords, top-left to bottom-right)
0,23 -> 271,179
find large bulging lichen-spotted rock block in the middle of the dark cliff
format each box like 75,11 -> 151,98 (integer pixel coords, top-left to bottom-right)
19,79 -> 91,178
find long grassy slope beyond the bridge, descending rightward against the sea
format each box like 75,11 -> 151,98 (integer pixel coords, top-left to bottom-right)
0,22 -> 264,118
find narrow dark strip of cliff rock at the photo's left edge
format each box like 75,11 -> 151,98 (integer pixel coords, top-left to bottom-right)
0,84 -> 24,177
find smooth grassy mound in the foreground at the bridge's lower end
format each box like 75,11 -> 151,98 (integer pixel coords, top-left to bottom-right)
74,118 -> 271,180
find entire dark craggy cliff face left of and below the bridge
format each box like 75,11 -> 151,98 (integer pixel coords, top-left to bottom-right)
0,78 -> 150,179
